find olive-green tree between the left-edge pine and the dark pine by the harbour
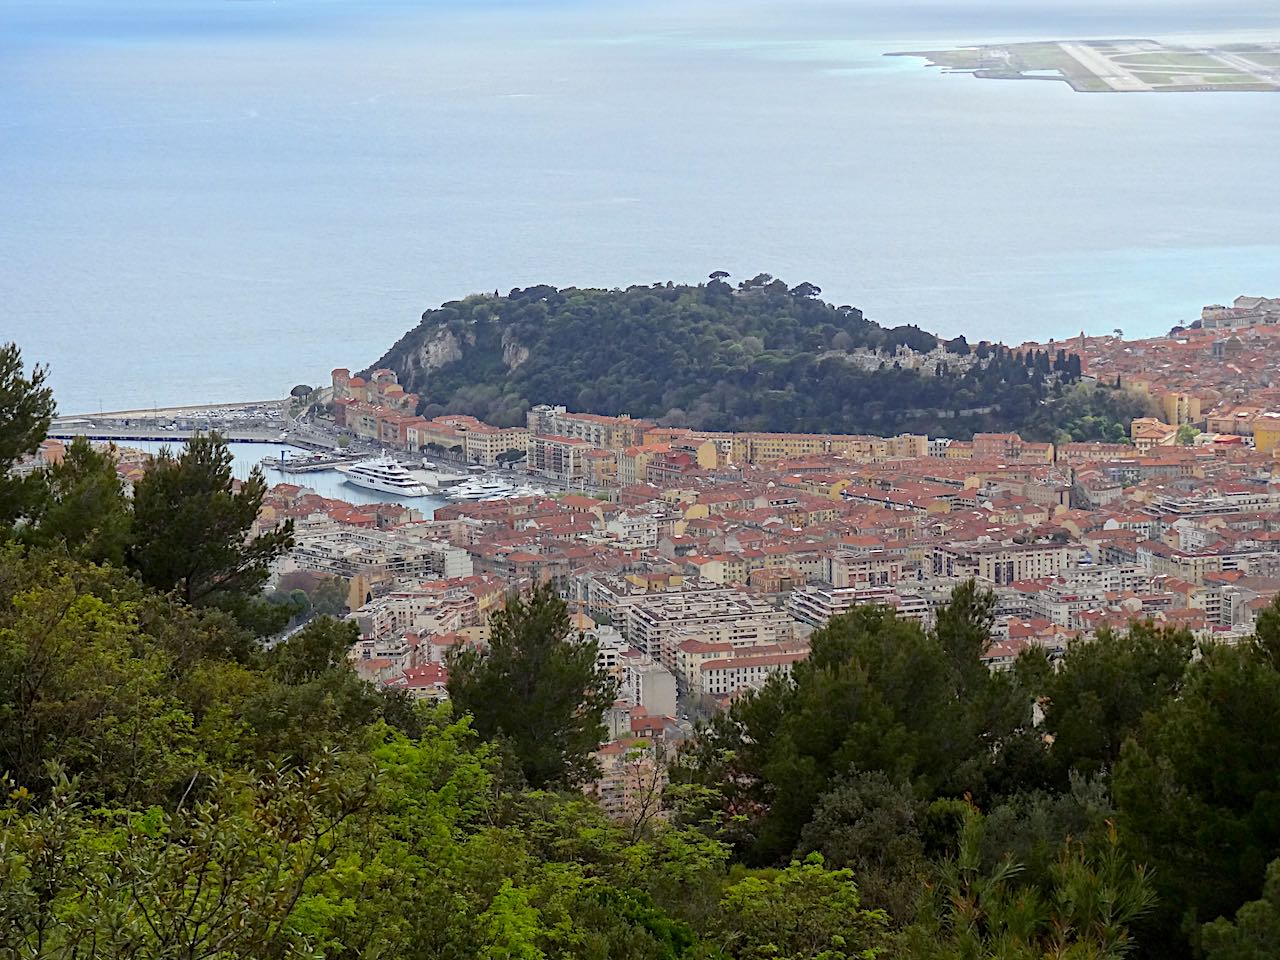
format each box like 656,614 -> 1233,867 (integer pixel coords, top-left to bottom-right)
24,436 -> 133,566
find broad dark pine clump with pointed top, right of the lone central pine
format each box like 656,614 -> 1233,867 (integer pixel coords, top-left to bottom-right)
692,584 -> 1032,861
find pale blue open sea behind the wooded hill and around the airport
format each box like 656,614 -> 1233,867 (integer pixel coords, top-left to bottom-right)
0,0 -> 1280,411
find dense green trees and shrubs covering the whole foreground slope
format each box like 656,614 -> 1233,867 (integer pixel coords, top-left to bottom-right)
0,352 -> 1280,960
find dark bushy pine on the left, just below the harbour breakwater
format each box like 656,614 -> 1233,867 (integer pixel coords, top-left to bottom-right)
128,434 -> 293,608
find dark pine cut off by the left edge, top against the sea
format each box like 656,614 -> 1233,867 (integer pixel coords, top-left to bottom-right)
0,343 -> 54,526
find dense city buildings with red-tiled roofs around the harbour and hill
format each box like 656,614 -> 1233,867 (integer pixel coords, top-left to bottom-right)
309,327 -> 1280,817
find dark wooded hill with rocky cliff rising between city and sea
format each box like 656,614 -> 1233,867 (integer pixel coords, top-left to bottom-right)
375,273 -> 1121,439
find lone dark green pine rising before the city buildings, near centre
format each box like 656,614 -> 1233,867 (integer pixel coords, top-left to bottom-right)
449,582 -> 617,787
